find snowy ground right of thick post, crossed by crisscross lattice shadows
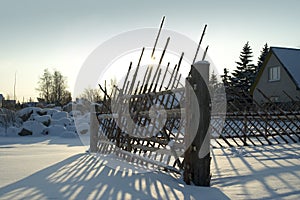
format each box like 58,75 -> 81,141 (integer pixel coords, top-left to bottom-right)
212,144 -> 300,199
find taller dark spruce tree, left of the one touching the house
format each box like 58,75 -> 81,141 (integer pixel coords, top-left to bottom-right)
231,42 -> 255,91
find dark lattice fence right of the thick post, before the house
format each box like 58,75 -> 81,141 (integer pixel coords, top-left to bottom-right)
211,90 -> 300,147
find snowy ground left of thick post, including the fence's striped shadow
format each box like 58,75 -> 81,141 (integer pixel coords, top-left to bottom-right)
0,137 -> 228,199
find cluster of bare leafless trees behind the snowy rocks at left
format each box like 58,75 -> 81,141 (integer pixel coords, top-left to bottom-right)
36,69 -> 72,105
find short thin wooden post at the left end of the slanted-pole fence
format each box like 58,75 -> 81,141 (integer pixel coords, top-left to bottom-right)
90,104 -> 99,153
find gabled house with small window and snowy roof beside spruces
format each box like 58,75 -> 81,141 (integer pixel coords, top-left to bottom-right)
250,47 -> 300,103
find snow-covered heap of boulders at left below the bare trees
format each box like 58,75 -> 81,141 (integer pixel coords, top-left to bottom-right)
0,104 -> 81,137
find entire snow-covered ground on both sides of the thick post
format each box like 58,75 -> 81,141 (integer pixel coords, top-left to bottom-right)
0,135 -> 300,199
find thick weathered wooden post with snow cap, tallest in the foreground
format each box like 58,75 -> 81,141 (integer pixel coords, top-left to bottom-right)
184,61 -> 211,186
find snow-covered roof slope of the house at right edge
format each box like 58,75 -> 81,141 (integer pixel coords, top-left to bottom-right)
271,47 -> 300,88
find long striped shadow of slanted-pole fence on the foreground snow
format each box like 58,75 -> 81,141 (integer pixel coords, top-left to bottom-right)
0,154 -> 229,199
